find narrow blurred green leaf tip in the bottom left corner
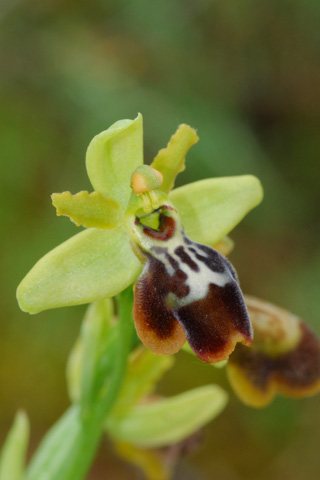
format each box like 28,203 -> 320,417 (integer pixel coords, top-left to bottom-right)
0,412 -> 29,480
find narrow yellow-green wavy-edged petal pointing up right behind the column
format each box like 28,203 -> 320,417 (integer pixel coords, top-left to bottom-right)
151,124 -> 199,193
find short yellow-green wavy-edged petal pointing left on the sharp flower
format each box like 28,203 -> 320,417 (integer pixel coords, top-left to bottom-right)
51,192 -> 123,230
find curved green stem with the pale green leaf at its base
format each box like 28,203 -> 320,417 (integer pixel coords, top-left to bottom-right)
24,287 -> 133,480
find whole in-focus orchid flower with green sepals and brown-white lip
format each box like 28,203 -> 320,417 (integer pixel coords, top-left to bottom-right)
18,115 -> 262,363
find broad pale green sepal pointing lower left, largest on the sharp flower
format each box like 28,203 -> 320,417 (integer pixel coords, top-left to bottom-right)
17,228 -> 141,313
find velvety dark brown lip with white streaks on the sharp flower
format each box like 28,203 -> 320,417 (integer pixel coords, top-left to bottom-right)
133,204 -> 252,363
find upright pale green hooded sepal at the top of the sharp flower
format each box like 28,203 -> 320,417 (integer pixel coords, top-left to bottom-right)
86,114 -> 143,208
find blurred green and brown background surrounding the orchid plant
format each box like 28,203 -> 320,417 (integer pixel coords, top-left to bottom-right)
0,0 -> 320,480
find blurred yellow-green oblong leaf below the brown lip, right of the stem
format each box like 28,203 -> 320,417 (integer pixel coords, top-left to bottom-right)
108,385 -> 227,448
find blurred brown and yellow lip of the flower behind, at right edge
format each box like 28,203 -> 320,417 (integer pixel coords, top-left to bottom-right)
227,296 -> 320,407
